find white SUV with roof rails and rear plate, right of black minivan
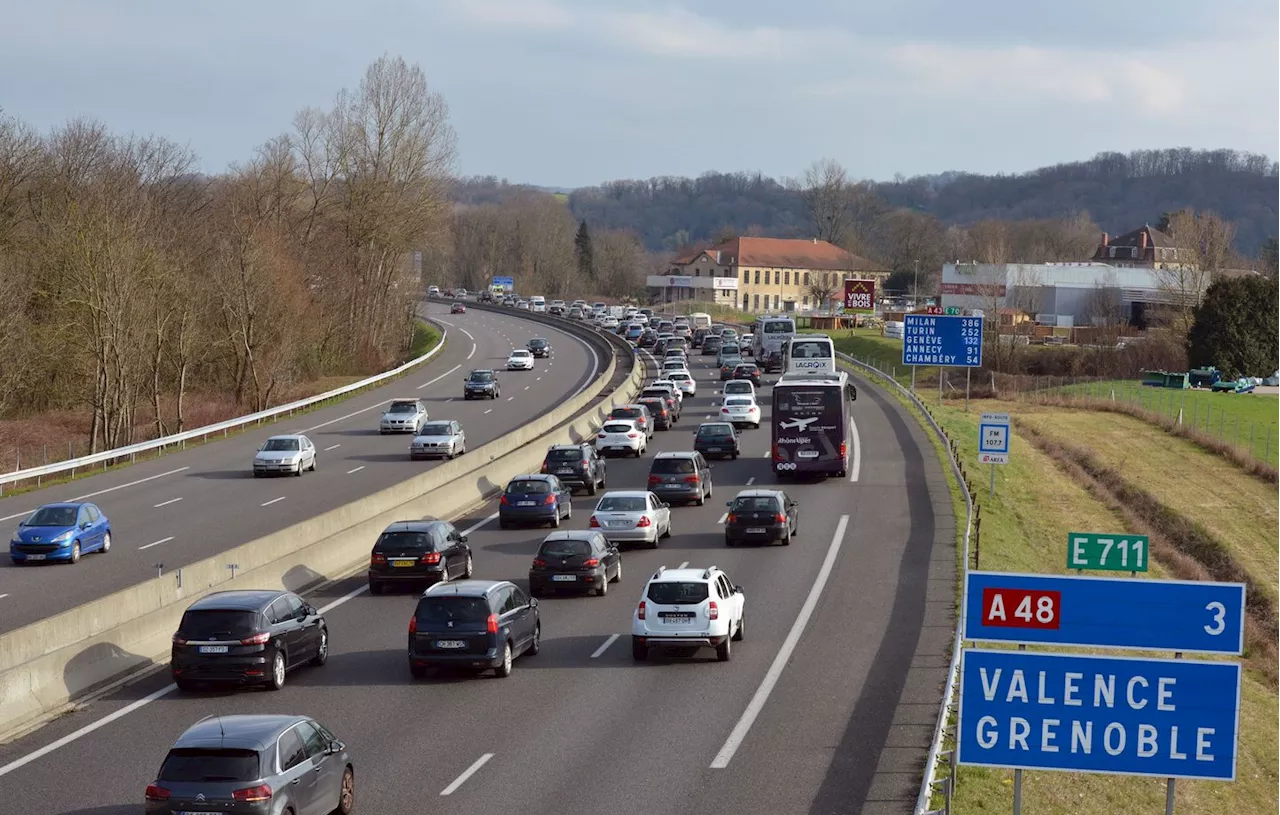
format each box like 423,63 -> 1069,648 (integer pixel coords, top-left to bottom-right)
631,566 -> 746,663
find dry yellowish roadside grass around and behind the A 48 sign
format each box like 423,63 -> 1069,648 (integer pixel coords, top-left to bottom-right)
934,400 -> 1280,815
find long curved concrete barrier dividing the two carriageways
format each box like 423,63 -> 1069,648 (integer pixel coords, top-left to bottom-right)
0,322 -> 644,740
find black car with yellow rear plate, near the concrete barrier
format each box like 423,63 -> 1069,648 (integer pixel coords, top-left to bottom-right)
367,518 -> 475,594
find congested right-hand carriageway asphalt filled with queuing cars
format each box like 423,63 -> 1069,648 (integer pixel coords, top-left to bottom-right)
0,345 -> 955,815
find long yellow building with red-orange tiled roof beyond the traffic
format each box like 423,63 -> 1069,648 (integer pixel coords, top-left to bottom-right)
665,238 -> 888,313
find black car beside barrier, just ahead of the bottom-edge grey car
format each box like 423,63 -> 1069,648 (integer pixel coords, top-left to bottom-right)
169,589 -> 329,691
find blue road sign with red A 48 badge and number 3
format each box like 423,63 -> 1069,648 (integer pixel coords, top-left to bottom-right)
964,572 -> 1244,655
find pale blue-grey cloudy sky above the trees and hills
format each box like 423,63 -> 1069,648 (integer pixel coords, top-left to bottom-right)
0,0 -> 1280,187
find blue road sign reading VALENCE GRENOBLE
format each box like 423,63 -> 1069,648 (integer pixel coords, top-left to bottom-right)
957,647 -> 1240,780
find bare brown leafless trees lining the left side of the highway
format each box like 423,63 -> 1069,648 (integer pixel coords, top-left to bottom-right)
0,56 -> 456,450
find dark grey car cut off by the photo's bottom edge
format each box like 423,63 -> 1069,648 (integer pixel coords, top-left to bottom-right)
145,714 -> 356,815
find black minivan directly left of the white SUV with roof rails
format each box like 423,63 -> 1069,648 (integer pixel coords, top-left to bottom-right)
408,580 -> 543,679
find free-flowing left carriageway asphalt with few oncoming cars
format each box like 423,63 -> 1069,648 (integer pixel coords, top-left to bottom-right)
0,303 -> 608,631
